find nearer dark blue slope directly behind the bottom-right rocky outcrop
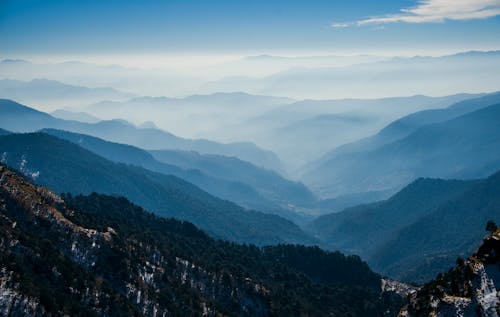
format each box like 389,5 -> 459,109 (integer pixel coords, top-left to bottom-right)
371,172 -> 500,281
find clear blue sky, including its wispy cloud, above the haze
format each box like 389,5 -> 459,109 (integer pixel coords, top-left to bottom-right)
0,0 -> 500,55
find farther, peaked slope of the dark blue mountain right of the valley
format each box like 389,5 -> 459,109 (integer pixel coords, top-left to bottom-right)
308,179 -> 477,256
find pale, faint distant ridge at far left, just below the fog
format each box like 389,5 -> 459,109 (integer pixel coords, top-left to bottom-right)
0,79 -> 133,110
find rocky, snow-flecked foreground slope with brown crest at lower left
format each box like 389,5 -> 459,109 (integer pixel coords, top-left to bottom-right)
0,165 -> 269,316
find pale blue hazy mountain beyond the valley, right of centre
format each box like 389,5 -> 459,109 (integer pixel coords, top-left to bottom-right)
206,94 -> 477,169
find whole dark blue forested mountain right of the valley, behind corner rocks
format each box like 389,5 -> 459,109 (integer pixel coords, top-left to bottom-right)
308,172 -> 500,283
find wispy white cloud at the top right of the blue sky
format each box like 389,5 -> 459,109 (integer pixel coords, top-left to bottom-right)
332,0 -> 500,27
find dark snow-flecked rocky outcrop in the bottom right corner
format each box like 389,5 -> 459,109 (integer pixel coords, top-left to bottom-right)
399,226 -> 500,317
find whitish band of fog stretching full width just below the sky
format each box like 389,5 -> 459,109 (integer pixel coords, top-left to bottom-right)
0,51 -> 500,99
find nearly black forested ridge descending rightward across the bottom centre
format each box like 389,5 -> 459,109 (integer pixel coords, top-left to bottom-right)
58,190 -> 397,316
